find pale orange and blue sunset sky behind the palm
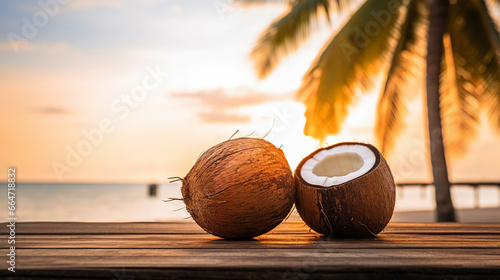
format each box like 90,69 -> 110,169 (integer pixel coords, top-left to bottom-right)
0,0 -> 500,183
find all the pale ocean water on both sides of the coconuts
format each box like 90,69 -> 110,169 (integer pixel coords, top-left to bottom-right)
0,183 -> 500,222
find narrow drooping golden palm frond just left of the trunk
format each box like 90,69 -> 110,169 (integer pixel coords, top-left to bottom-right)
375,0 -> 428,153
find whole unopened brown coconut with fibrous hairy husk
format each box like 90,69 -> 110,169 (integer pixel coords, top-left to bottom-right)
182,138 -> 295,239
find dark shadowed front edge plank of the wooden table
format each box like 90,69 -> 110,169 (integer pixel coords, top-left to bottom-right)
0,267 -> 499,280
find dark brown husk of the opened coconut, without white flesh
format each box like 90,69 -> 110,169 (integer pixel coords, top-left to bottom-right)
295,143 -> 396,238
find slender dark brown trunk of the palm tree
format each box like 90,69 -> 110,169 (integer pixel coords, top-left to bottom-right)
426,0 -> 455,222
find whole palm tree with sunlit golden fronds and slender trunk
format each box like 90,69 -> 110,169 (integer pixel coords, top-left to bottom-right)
246,0 -> 500,221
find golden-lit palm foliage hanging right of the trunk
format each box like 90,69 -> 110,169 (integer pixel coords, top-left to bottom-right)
442,0 -> 500,150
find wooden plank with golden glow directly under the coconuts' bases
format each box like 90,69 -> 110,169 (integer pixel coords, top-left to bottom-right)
0,233 -> 500,250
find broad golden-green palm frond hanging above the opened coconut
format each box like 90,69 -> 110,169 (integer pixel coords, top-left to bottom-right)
297,0 -> 409,139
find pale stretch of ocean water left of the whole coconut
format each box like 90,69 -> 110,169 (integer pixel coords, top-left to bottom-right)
0,183 -> 189,222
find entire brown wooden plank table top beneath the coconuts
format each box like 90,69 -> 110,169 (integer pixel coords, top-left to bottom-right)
0,222 -> 500,280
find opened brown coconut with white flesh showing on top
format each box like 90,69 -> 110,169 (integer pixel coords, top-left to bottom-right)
295,142 -> 396,238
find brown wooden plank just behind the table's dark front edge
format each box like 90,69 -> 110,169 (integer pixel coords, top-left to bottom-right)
1,246 -> 500,271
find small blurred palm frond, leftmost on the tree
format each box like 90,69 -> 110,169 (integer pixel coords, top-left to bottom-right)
250,0 -> 330,78
